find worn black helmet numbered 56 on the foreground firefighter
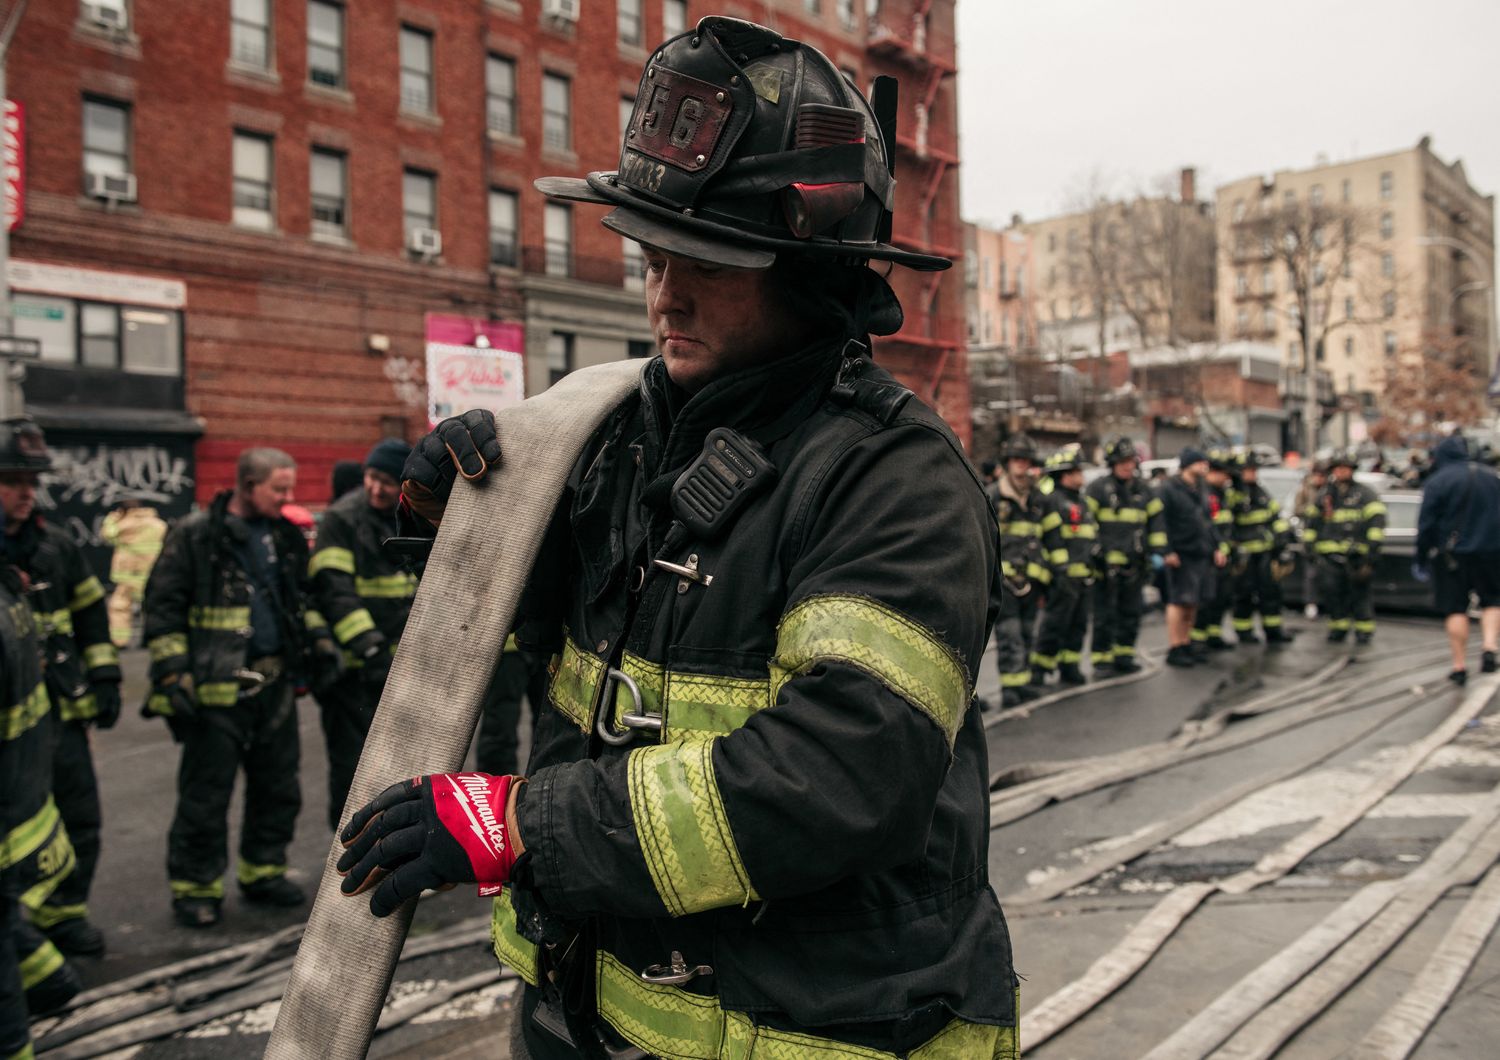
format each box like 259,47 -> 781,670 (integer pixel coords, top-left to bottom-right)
536,15 -> 953,334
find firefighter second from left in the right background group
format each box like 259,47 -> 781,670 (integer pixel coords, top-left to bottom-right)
1032,445 -> 1100,688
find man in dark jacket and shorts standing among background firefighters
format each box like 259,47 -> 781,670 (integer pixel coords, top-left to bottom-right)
1161,445 -> 1226,666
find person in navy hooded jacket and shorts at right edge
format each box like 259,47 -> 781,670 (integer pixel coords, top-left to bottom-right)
1415,435 -> 1500,685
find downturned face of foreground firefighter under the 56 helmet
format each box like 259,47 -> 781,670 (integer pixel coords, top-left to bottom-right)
642,246 -> 812,394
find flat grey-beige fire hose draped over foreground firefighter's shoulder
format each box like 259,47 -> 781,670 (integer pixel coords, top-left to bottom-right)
266,361 -> 641,1060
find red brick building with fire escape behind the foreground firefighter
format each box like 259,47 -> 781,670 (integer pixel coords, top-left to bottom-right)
8,0 -> 969,572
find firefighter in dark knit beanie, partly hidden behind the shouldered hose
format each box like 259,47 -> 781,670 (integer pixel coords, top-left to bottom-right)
308,438 -> 417,829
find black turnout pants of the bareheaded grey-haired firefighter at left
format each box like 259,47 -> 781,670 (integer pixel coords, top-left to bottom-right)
167,675 -> 302,898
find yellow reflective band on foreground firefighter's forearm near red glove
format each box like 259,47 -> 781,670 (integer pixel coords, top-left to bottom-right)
627,738 -> 761,916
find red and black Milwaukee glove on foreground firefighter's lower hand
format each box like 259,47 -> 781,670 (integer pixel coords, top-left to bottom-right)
338,774 -> 525,916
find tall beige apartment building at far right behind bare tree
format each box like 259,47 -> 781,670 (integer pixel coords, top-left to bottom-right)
1217,136 -> 1496,419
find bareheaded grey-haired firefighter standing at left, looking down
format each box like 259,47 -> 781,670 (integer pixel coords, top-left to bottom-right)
144,448 -> 338,928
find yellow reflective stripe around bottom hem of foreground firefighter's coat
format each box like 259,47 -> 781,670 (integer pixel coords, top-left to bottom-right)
594,949 -> 1019,1060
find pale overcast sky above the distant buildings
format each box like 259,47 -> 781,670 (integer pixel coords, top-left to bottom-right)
957,0 -> 1500,225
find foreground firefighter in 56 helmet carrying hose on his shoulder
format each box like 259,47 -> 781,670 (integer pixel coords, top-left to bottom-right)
339,16 -> 1017,1060
